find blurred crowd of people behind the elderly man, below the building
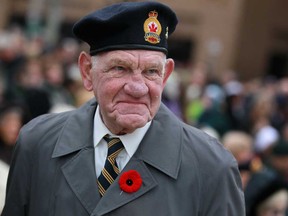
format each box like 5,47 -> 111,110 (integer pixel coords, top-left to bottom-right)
0,24 -> 288,216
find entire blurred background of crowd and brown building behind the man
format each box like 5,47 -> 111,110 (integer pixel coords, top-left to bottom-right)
0,0 -> 288,216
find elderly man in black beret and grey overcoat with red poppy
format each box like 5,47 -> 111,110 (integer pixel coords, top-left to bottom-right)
3,1 -> 244,216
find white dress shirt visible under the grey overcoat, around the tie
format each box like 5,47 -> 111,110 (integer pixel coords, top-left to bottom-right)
93,106 -> 151,178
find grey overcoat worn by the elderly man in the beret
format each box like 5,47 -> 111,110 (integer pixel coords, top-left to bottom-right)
2,100 -> 245,216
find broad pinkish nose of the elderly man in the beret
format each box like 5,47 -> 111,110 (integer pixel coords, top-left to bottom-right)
124,74 -> 149,97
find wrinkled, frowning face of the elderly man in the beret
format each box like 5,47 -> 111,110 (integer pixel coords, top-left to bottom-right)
79,50 -> 174,134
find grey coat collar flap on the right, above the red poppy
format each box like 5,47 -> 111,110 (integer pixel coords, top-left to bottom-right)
135,104 -> 183,179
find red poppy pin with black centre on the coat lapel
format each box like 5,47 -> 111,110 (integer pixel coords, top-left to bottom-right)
119,170 -> 142,193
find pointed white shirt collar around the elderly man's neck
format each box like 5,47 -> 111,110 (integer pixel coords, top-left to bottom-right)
93,106 -> 151,157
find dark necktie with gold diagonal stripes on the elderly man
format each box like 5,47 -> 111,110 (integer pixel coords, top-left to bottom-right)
97,135 -> 124,196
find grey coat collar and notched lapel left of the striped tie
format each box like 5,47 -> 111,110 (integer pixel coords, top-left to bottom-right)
52,100 -> 100,214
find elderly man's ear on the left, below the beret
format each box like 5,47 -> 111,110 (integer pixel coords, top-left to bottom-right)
78,52 -> 93,91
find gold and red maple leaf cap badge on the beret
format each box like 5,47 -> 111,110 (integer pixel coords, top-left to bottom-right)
144,11 -> 162,44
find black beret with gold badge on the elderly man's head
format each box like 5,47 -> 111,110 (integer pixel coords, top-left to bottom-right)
73,1 -> 178,55
